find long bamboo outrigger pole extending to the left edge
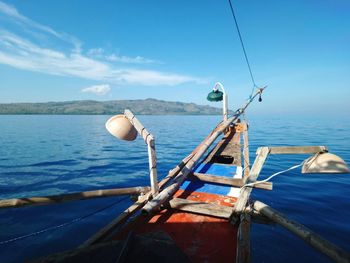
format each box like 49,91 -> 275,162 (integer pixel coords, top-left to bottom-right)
0,186 -> 150,208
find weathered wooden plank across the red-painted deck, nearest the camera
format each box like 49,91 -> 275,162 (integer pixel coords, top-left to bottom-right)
169,198 -> 232,219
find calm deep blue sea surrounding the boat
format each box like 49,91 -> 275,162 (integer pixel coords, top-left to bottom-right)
0,115 -> 350,262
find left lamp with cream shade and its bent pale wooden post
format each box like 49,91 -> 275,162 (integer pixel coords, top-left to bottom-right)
106,110 -> 159,196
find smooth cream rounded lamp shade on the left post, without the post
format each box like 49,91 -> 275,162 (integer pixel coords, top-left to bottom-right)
106,114 -> 137,141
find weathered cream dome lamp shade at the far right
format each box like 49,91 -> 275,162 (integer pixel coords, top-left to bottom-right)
301,152 -> 350,173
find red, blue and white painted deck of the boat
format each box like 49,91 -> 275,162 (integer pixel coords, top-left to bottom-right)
113,125 -> 242,262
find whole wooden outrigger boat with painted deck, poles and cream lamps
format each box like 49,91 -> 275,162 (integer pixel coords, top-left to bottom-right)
0,86 -> 350,262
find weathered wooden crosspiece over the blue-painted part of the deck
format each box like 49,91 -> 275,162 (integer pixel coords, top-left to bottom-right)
191,173 -> 273,190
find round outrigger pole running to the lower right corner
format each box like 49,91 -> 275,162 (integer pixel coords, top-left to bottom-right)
253,201 -> 350,263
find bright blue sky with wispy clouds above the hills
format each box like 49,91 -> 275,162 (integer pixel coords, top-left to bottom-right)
0,0 -> 350,116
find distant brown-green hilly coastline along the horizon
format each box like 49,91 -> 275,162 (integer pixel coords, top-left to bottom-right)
0,99 -> 227,115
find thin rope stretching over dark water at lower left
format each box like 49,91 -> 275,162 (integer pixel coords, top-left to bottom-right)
0,196 -> 128,245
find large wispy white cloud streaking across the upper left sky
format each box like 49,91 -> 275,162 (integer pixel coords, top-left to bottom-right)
0,1 -> 203,86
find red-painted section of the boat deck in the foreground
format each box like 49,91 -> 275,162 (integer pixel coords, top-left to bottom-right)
116,190 -> 237,262
